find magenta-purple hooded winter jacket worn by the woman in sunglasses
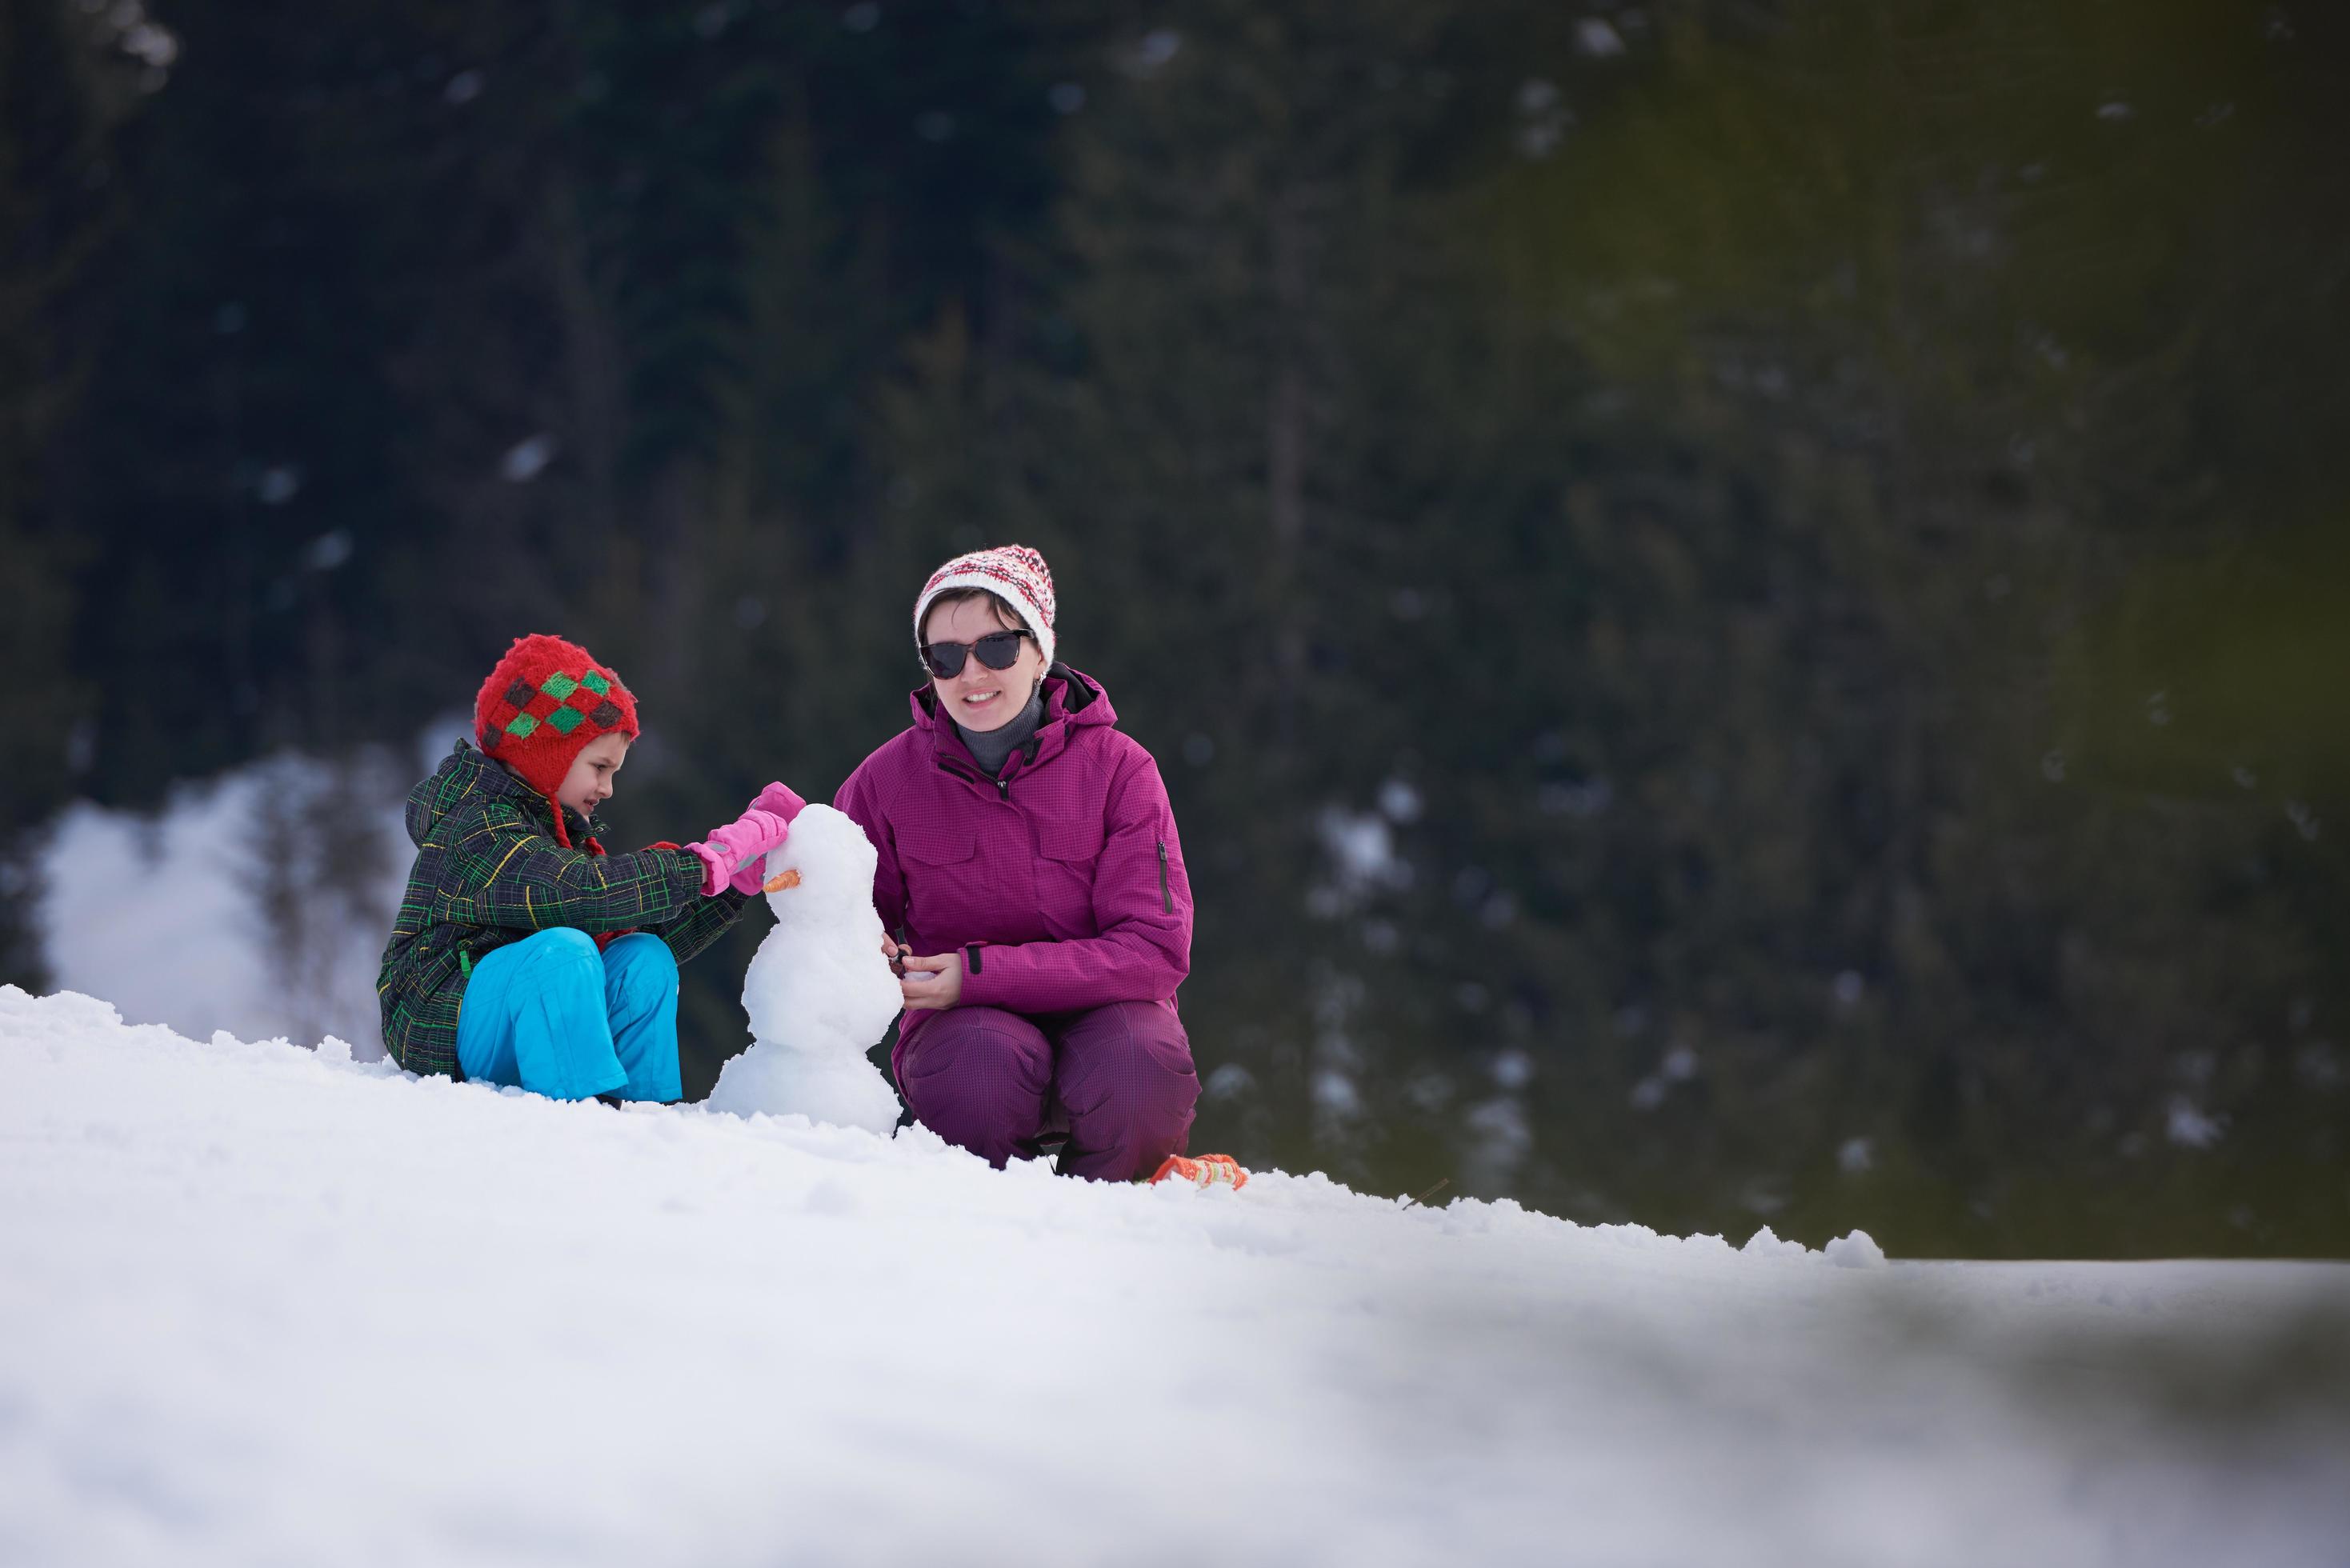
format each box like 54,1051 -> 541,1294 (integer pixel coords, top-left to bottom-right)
832,666 -> 1191,1051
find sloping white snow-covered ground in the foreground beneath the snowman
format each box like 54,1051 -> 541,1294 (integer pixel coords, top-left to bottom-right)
14,987 -> 2350,1566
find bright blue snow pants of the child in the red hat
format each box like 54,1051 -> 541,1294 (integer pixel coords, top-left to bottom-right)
456,929 -> 682,1102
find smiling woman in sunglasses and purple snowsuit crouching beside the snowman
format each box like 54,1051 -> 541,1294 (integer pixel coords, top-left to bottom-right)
835,546 -> 1239,1180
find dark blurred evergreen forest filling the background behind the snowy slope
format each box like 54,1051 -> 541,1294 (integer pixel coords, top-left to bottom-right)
0,0 -> 2350,1255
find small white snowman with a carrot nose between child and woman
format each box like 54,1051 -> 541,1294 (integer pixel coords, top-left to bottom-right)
710,806 -> 905,1138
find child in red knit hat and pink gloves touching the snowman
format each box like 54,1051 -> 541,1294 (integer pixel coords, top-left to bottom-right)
376,634 -> 802,1102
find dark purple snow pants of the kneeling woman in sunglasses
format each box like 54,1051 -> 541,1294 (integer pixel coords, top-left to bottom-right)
895,1002 -> 1199,1182
